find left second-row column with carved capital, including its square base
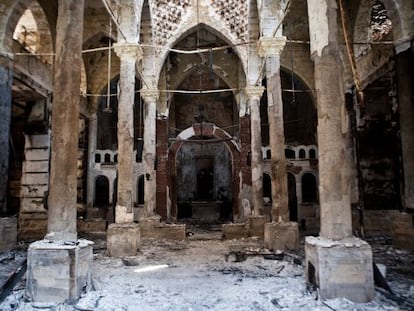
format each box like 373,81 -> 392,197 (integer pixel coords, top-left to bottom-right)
107,42 -> 142,257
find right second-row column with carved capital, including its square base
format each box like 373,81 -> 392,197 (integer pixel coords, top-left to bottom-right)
258,37 -> 299,250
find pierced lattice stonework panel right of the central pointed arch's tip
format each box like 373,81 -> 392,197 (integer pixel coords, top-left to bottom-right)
211,0 -> 249,42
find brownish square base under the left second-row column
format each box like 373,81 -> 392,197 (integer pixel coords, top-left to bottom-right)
106,223 -> 141,257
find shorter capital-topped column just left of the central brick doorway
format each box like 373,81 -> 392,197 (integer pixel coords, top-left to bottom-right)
141,89 -> 159,218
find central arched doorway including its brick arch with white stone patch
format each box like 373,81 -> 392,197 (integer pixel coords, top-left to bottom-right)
169,123 -> 240,224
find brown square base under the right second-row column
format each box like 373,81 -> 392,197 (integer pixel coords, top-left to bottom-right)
264,222 -> 299,251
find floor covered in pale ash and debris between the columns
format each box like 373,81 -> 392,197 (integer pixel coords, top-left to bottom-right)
0,234 -> 414,311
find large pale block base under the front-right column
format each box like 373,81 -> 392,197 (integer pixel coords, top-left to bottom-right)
305,236 -> 374,303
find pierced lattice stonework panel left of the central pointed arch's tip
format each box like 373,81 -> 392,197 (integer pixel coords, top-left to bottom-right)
152,0 -> 191,45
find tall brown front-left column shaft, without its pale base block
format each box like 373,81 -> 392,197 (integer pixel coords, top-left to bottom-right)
47,0 -> 84,241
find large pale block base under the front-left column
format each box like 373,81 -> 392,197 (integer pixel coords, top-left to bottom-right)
25,240 -> 93,303
